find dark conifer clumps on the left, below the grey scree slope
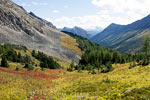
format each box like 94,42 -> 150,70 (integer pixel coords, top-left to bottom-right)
0,44 -> 61,70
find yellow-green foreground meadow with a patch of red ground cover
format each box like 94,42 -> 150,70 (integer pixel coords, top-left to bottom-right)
0,64 -> 150,100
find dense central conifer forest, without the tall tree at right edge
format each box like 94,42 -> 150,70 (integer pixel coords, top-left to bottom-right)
62,32 -> 142,73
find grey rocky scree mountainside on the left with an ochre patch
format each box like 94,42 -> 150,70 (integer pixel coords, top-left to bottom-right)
0,0 -> 80,62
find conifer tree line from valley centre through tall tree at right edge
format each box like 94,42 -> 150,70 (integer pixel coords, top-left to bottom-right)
63,31 -> 150,73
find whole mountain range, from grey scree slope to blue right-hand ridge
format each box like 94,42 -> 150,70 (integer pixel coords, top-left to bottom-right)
0,0 -> 150,62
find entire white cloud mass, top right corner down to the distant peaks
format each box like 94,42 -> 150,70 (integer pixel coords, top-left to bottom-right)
47,0 -> 150,29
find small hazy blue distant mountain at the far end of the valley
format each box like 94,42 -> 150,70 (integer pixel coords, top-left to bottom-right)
61,26 -> 91,39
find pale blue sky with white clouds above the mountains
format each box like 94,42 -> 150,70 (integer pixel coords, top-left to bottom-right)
13,0 -> 150,29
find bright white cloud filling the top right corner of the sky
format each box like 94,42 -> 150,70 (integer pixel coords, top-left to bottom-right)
91,0 -> 150,24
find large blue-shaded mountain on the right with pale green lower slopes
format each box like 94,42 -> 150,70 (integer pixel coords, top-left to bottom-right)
91,15 -> 150,53
